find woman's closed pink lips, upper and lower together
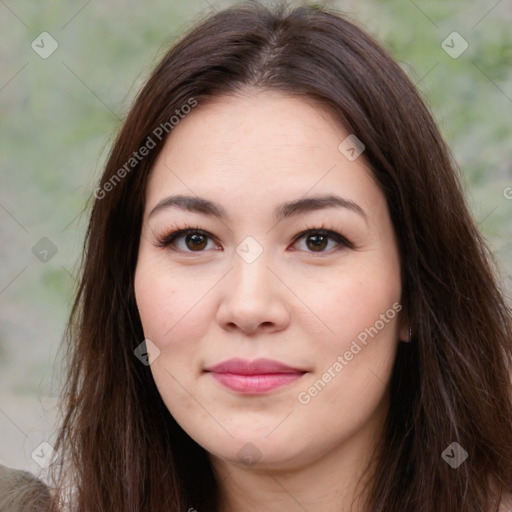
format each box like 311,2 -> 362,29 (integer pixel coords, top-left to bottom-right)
205,358 -> 306,394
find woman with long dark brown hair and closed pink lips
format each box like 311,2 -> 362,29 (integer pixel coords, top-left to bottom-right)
42,4 -> 512,512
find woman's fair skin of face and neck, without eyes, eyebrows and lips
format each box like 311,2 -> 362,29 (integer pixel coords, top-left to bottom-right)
135,89 -> 407,512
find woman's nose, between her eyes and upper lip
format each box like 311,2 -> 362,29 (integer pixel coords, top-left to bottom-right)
217,249 -> 290,334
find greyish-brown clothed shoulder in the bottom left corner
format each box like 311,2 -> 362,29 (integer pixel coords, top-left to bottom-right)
0,465 -> 51,512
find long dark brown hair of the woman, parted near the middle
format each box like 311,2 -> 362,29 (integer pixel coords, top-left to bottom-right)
50,3 -> 512,512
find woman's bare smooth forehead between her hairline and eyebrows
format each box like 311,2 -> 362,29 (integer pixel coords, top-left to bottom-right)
147,91 -> 382,219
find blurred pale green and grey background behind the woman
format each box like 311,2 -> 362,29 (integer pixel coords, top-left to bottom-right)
0,0 -> 512,472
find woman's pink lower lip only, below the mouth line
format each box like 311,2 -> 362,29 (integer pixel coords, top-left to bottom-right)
211,372 -> 303,395
